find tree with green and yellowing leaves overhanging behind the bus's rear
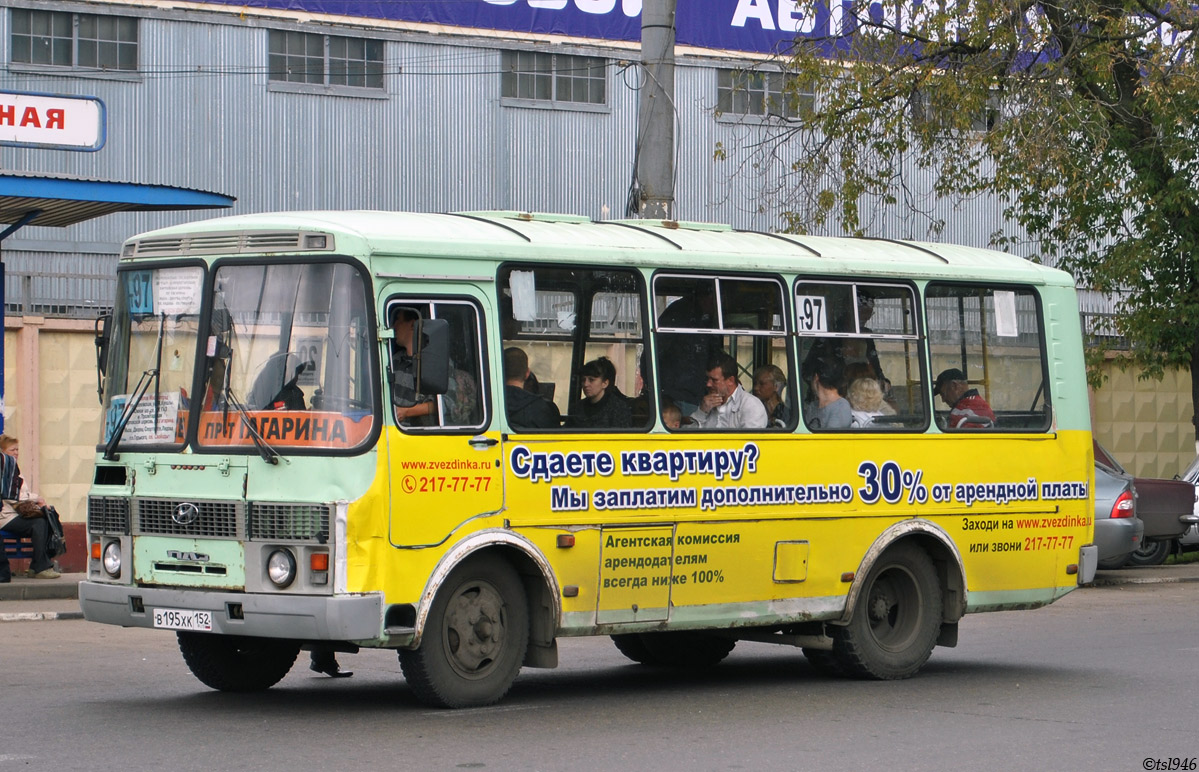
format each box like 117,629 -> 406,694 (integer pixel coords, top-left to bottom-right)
738,0 -> 1199,441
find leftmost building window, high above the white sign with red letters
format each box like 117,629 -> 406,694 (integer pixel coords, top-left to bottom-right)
12,8 -> 138,72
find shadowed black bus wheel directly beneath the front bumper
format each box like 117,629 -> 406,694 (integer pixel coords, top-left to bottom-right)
175,632 -> 300,692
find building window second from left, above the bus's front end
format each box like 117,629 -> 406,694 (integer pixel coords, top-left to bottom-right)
269,30 -> 384,89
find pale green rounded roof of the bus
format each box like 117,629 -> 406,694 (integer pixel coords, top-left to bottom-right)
122,211 -> 1074,287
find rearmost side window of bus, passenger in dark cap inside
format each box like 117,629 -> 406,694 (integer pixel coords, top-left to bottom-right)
924,284 -> 1050,432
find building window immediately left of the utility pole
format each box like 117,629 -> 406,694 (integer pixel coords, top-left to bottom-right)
502,50 -> 608,104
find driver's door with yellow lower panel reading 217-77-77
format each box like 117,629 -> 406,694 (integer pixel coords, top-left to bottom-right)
384,291 -> 504,547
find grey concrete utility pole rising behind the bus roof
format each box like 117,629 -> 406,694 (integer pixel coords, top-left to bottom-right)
635,0 -> 676,219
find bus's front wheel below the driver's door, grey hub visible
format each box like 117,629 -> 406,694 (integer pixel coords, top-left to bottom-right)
399,555 -> 529,707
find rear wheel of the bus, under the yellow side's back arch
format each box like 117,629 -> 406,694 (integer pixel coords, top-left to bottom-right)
833,544 -> 941,681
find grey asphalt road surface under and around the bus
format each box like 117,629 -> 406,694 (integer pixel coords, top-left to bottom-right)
9,583 -> 1199,772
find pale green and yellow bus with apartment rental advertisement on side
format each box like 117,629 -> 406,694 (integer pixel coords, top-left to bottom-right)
80,211 -> 1097,707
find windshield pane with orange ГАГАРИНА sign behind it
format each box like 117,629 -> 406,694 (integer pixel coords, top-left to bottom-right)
197,263 -> 375,448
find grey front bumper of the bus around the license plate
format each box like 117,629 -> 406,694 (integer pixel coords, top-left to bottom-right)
79,581 -> 382,641
